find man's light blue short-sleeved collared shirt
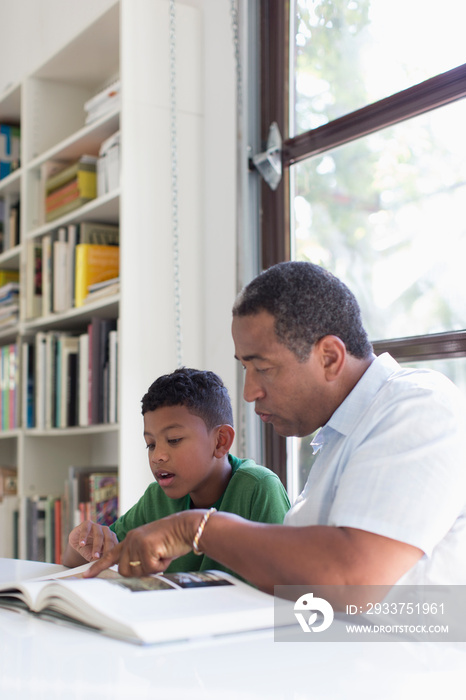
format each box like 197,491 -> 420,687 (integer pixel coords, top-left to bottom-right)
285,354 -> 466,583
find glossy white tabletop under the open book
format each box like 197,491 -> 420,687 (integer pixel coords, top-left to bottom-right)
0,559 -> 466,700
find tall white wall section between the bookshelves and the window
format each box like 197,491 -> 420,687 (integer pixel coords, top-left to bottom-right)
120,0 -> 236,509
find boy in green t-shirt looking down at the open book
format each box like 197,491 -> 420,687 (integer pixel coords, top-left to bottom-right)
63,367 -> 290,574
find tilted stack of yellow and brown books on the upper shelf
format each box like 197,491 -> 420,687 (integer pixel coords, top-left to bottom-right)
45,155 -> 97,222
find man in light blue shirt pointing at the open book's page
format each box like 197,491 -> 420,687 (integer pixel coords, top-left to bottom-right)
89,262 -> 466,593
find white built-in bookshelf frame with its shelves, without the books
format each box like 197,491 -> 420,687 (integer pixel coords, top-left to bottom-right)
0,3 -> 120,557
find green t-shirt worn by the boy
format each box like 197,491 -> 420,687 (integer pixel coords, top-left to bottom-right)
110,455 -> 290,577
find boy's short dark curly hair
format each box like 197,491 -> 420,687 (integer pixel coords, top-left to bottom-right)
141,367 -> 233,430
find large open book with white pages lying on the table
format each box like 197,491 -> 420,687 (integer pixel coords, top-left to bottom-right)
0,564 -> 280,644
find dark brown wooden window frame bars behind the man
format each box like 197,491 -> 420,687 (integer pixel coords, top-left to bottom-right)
260,0 -> 466,486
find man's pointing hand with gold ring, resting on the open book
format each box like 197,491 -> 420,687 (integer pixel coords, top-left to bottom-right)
84,510 -> 205,578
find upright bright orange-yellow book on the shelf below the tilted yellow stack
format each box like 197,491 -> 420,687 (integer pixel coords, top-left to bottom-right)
75,243 -> 120,307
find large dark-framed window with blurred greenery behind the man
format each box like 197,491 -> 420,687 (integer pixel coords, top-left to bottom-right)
261,0 -> 466,496
